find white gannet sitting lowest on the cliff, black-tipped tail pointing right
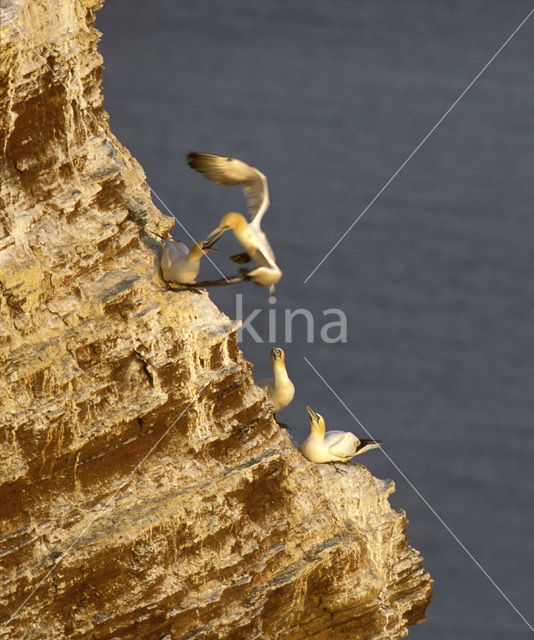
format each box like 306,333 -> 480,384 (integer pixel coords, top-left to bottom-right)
300,407 -> 382,462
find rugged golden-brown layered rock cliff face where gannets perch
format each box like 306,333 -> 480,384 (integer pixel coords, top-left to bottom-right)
0,0 -> 432,640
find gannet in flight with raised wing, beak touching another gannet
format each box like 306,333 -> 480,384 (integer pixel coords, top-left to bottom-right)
187,152 -> 282,295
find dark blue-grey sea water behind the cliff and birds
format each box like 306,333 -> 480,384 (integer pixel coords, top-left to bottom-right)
97,0 -> 534,640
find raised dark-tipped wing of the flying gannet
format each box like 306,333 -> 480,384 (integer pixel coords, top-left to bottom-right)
187,152 -> 269,227
